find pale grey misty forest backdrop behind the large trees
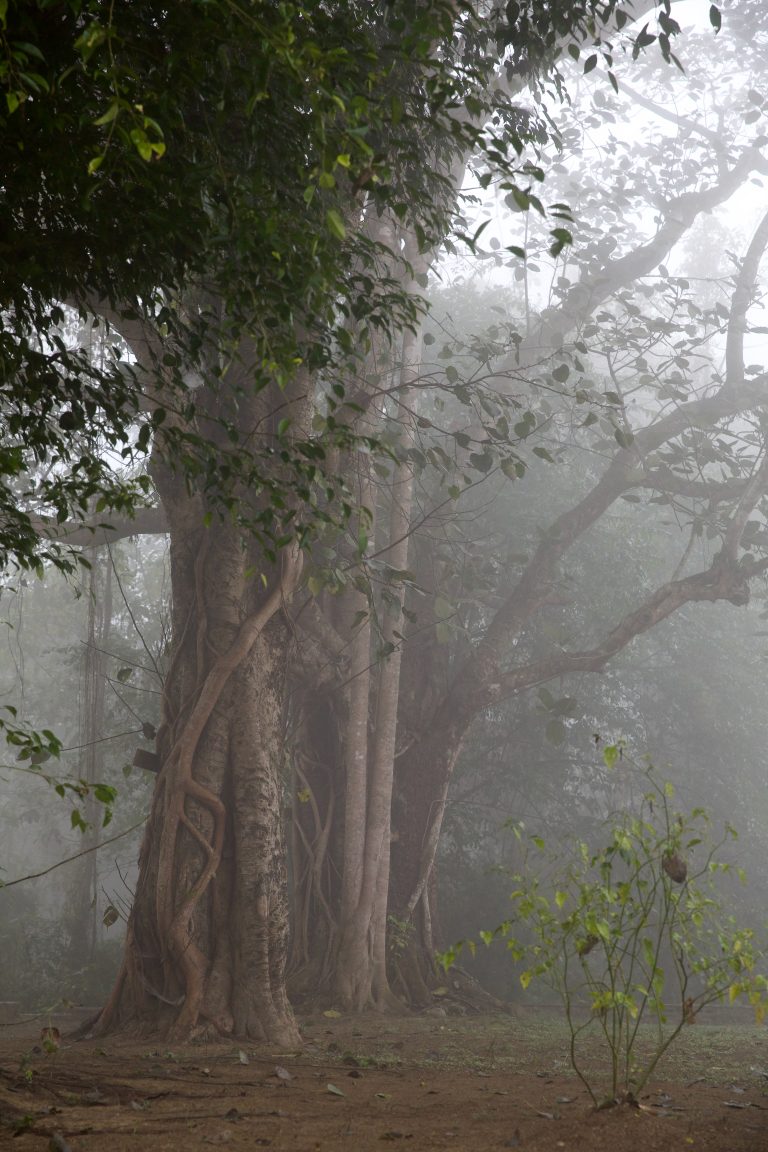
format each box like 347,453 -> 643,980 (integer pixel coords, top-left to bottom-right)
0,5 -> 768,1011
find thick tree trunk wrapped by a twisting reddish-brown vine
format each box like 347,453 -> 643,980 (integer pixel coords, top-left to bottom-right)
97,490 -> 301,1046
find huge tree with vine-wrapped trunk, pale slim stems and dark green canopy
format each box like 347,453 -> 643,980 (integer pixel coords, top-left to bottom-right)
6,3 -> 727,1043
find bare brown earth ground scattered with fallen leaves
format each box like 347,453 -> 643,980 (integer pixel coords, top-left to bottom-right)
0,1009 -> 768,1152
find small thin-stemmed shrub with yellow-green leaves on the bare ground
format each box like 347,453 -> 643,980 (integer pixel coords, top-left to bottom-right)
440,768 -> 766,1107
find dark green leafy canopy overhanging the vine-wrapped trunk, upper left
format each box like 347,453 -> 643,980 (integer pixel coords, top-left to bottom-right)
0,0 -> 695,567
